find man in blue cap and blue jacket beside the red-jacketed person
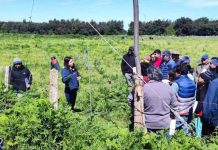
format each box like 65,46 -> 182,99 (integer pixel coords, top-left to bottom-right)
160,50 -> 176,80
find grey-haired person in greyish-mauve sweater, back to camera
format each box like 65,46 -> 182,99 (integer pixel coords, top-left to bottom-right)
144,67 -> 178,132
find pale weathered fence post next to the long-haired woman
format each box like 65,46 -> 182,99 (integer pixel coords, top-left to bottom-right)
49,69 -> 58,110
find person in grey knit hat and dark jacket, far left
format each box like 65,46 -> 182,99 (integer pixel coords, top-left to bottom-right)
9,58 -> 32,91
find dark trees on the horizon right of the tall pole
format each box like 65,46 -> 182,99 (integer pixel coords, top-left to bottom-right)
128,17 -> 218,36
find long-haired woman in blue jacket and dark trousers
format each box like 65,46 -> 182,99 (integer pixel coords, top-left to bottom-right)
61,57 -> 81,111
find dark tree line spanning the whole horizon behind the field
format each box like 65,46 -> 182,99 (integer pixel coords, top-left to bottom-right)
0,17 -> 218,36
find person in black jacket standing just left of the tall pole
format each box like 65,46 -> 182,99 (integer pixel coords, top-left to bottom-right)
121,46 -> 136,87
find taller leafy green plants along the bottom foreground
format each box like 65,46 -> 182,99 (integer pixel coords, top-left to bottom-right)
0,88 -> 218,150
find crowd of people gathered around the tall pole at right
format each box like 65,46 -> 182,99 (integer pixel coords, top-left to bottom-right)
121,47 -> 218,136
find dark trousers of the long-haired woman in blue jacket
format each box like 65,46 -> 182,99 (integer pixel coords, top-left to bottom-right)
65,88 -> 78,110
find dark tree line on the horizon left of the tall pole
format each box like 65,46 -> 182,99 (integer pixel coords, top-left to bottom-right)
0,19 -> 125,35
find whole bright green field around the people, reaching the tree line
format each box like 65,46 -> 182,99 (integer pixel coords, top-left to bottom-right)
0,34 -> 218,150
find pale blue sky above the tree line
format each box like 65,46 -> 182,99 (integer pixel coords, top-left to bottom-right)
0,0 -> 218,29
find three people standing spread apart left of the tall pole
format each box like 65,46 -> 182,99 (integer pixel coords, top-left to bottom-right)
9,56 -> 81,111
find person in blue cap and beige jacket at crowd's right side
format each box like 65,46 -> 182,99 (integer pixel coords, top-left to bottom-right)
194,54 -> 210,83
